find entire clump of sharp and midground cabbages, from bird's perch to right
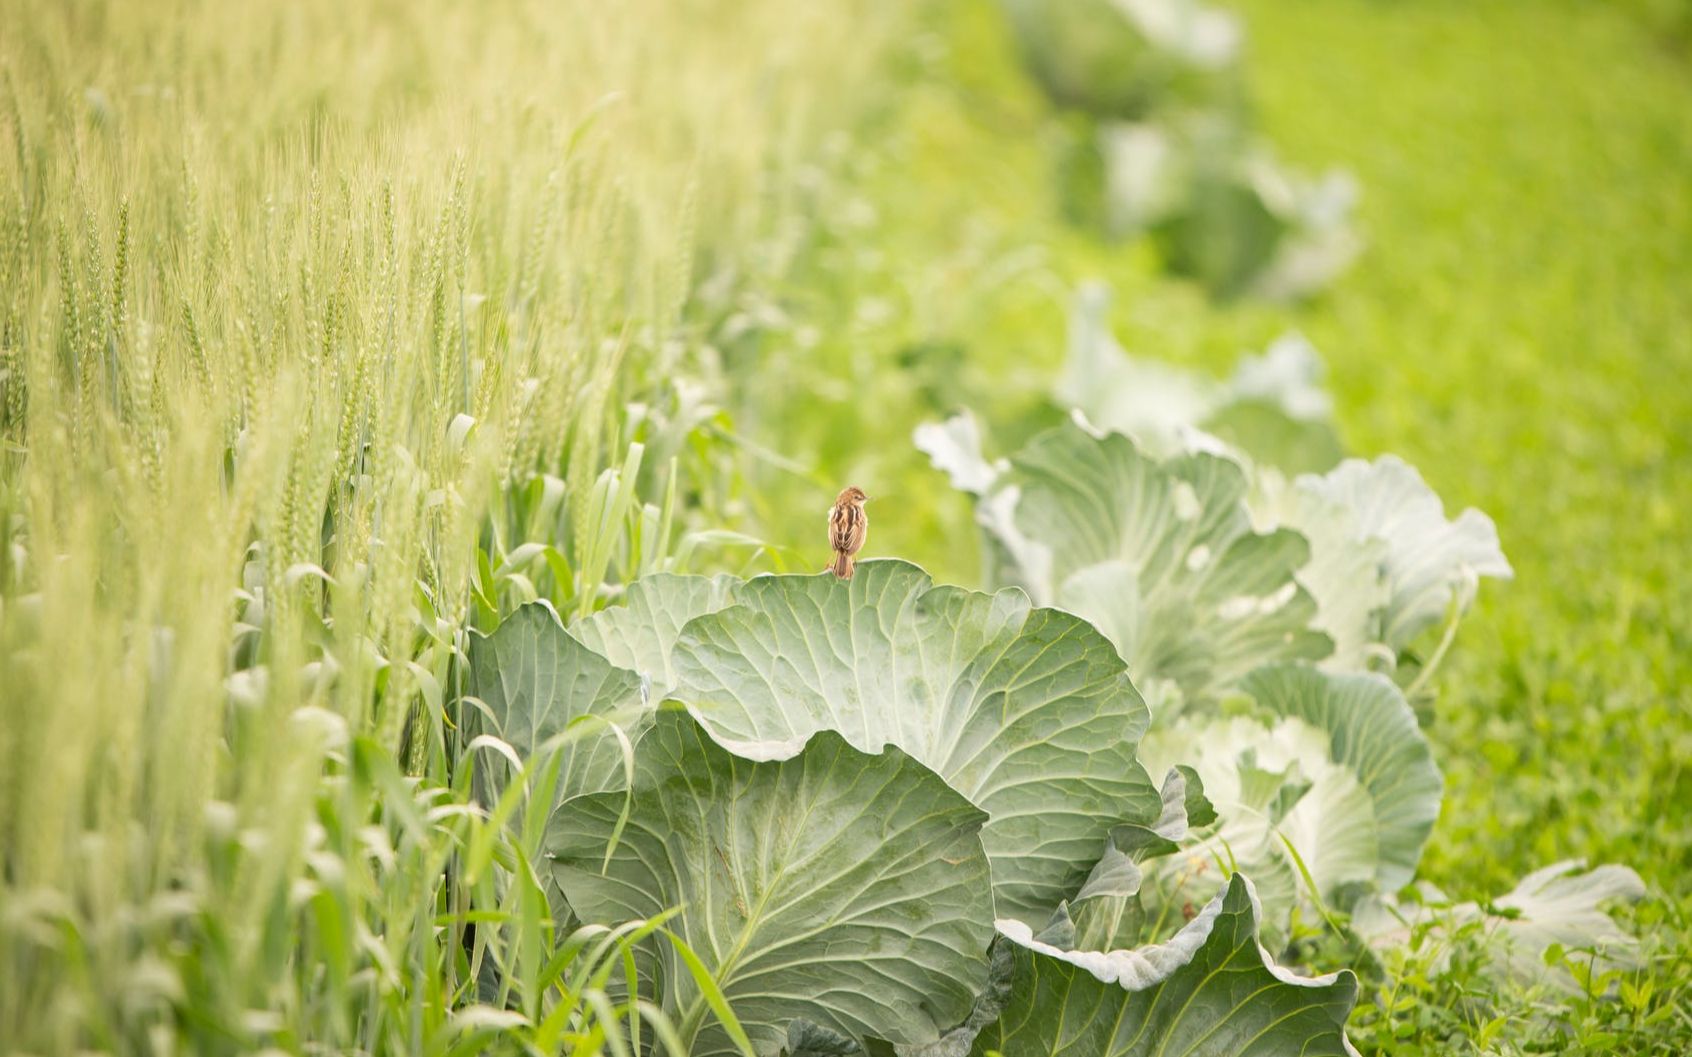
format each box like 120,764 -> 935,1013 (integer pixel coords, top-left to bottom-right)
460,291 -> 1640,1055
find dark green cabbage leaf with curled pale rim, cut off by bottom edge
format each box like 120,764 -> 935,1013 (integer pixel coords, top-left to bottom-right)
971,874 -> 1357,1057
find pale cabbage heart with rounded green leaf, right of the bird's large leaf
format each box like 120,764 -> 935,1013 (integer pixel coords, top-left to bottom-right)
1145,665 -> 1443,932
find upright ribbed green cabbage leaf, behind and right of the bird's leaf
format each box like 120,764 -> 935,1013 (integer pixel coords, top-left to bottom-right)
1005,423 -> 1332,704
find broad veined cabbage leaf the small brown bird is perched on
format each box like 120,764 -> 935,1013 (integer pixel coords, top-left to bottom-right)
659,561 -> 1159,920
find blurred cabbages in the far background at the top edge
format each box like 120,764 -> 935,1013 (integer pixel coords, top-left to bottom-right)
1003,0 -> 1359,301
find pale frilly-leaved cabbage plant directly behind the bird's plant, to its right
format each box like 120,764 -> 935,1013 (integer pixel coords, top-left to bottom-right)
917,375 -> 1509,939
